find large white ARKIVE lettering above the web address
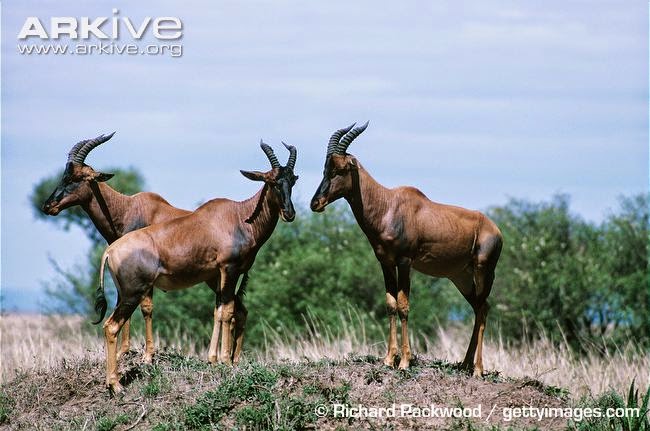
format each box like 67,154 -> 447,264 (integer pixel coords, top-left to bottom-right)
18,9 -> 183,40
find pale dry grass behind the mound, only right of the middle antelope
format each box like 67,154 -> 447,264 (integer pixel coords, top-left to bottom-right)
258,313 -> 650,398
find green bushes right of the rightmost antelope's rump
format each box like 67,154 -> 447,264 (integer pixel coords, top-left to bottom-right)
490,195 -> 648,348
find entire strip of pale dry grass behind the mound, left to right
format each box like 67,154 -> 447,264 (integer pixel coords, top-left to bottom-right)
0,315 -> 650,398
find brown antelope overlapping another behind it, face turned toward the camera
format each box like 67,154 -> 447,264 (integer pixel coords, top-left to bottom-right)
96,143 -> 298,392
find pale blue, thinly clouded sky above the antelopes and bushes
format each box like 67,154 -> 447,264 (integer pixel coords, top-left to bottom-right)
0,0 -> 648,311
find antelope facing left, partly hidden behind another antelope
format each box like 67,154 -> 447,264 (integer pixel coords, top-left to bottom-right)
43,132 -> 246,363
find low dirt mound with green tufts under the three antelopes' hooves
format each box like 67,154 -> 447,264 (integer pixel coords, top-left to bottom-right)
0,352 -> 568,430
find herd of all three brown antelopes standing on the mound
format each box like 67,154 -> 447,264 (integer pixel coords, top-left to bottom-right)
43,123 -> 502,393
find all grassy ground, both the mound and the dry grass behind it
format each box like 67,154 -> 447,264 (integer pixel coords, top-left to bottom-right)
0,315 -> 650,431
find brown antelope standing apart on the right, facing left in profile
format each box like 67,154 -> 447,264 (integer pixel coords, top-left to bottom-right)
311,123 -> 502,376
